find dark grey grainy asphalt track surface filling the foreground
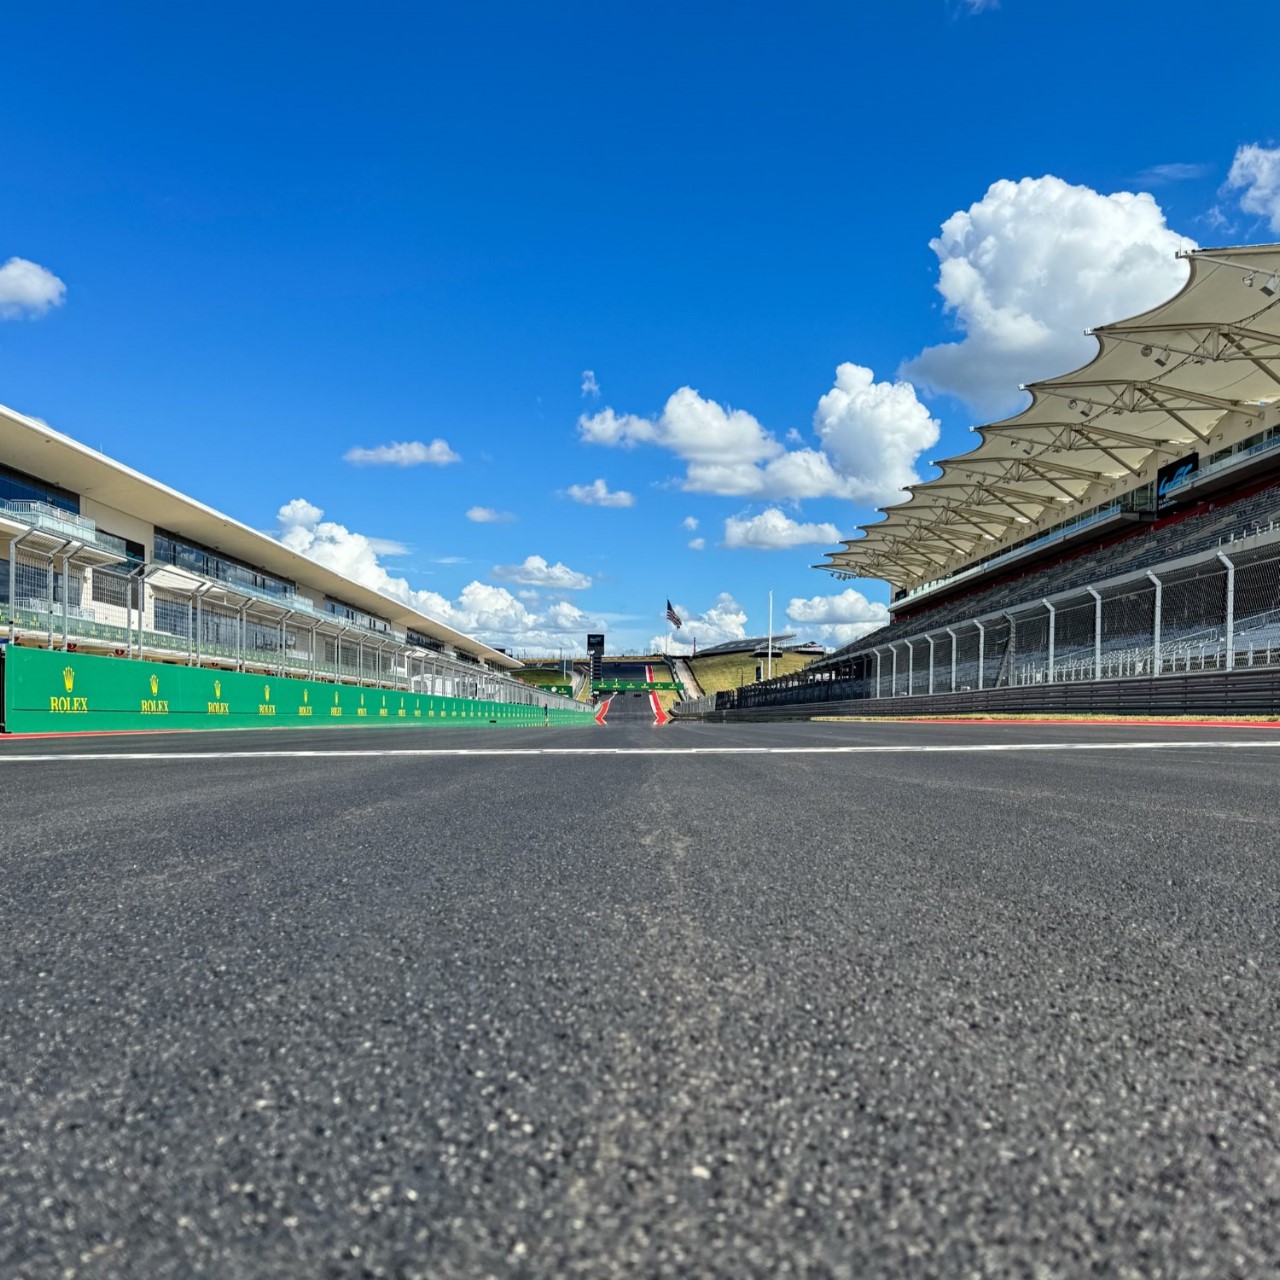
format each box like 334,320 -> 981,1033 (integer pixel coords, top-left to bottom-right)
0,722 -> 1280,1280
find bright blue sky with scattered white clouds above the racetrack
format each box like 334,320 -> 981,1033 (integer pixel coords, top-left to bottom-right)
0,0 -> 1280,652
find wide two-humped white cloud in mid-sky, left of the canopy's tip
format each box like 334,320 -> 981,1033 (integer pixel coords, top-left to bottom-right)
579,364 -> 938,503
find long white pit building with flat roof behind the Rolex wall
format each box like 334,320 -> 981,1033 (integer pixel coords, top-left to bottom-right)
0,407 -> 580,737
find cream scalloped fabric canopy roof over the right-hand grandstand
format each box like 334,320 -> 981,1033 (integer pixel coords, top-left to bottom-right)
814,244 -> 1280,586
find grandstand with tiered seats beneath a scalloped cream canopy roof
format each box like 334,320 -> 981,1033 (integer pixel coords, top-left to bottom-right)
682,244 -> 1280,714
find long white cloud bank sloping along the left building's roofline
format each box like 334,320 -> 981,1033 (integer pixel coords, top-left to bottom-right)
278,498 -> 604,652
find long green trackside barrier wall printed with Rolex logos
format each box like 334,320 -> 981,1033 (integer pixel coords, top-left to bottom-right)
4,645 -> 594,733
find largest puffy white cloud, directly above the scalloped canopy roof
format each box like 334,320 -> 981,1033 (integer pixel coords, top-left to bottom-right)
902,175 -> 1194,416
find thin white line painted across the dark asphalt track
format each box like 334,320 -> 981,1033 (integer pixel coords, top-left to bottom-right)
0,737 -> 1280,764
